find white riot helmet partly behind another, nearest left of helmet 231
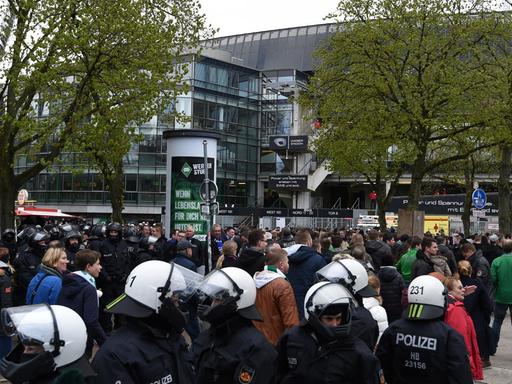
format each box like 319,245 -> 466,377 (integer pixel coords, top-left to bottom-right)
316,259 -> 377,297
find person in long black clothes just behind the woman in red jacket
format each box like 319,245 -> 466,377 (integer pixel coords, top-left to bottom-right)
457,260 -> 496,368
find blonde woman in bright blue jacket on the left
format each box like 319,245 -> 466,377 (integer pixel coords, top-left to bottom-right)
25,247 -> 69,304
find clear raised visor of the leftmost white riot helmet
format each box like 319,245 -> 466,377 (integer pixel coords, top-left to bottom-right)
0,304 -> 55,346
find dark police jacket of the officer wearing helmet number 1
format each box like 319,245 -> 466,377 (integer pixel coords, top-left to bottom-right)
92,318 -> 194,384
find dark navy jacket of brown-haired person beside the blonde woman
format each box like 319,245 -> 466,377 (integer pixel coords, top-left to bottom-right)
58,273 -> 107,345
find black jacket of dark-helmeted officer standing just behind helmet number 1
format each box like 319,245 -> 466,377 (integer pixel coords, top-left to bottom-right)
100,239 -> 130,283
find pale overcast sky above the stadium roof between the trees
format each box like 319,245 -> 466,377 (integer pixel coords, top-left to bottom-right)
200,0 -> 338,37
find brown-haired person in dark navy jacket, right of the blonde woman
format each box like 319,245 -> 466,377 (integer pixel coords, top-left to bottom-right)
58,249 -> 107,356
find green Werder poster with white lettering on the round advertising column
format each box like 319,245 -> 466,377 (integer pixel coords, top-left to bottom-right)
171,156 -> 214,235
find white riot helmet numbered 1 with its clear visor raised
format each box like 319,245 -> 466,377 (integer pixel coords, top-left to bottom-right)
106,260 -> 203,318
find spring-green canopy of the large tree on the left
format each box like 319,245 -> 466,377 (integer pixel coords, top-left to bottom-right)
0,0 -> 210,227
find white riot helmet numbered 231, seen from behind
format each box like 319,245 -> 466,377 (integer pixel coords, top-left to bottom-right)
407,275 -> 447,320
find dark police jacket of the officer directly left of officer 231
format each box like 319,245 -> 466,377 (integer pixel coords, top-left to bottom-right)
277,321 -> 380,384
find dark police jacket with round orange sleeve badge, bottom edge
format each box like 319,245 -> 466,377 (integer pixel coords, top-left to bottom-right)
192,315 -> 277,384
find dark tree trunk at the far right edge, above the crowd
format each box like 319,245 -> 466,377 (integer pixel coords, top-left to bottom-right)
498,145 -> 512,233
